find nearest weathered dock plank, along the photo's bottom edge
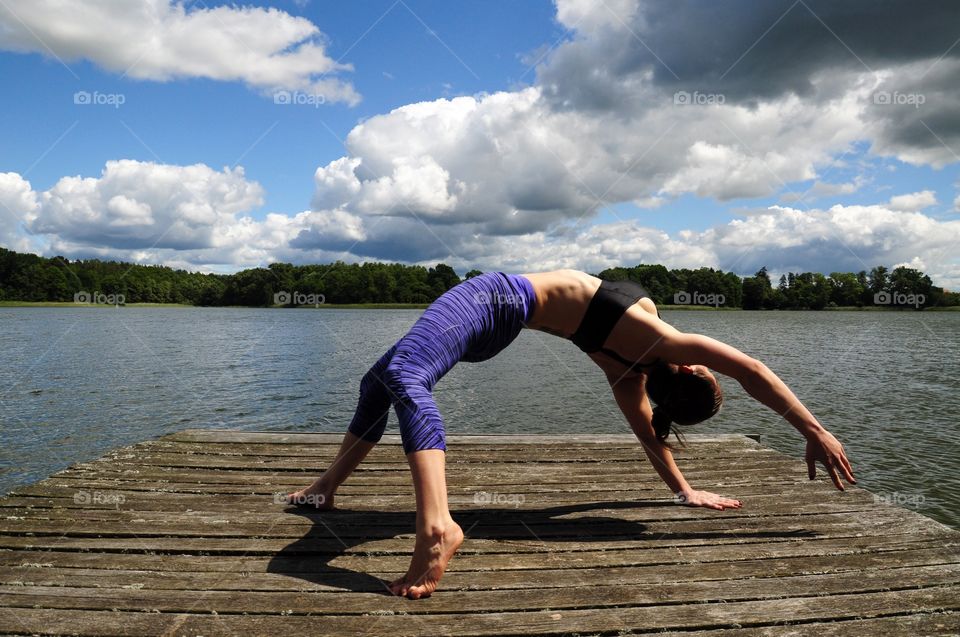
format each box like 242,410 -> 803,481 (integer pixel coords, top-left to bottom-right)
0,587 -> 960,637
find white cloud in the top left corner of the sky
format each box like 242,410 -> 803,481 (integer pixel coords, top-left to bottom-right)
0,0 -> 360,104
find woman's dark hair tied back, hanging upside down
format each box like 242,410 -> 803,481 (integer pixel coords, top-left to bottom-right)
646,362 -> 723,446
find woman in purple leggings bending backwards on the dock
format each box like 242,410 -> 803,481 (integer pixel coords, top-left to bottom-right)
287,270 -> 856,599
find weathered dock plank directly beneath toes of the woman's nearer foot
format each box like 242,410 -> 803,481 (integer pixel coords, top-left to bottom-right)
0,565 -> 960,615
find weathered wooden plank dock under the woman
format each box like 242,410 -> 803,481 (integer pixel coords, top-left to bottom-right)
0,430 -> 960,637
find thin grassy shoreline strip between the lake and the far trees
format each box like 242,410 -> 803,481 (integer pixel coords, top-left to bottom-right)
0,301 -> 960,312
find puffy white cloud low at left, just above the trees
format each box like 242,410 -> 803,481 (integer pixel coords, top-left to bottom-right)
6,160 -> 378,272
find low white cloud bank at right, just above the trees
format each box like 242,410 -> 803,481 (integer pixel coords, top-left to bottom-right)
512,205 -> 960,288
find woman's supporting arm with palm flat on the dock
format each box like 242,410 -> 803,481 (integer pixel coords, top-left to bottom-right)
608,376 -> 741,511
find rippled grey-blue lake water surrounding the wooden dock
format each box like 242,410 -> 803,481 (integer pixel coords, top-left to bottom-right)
0,308 -> 960,528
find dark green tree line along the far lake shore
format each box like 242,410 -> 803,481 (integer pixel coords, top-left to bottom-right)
0,248 -> 960,309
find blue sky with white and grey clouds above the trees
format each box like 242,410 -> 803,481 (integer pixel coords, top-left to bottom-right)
0,0 -> 960,290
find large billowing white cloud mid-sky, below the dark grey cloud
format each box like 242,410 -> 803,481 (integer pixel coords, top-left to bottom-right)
302,77 -> 866,235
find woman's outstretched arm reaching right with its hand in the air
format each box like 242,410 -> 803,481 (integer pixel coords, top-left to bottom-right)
655,332 -> 856,491
